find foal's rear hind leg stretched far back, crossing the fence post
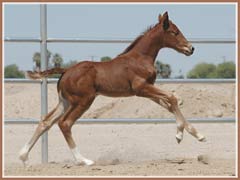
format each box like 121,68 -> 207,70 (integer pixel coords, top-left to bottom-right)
19,102 -> 64,163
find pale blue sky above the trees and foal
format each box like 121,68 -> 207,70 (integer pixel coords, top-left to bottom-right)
4,3 -> 236,77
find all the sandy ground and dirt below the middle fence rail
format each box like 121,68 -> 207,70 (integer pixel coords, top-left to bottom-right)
4,84 -> 236,176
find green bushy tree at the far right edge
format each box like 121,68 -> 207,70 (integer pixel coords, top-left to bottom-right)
216,61 -> 236,78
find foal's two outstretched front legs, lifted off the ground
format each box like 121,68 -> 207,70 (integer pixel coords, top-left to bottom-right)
136,84 -> 206,143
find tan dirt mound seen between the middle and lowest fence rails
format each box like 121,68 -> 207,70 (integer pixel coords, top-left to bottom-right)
4,84 -> 236,119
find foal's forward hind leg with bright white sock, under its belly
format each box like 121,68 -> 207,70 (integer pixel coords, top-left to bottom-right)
58,97 -> 94,165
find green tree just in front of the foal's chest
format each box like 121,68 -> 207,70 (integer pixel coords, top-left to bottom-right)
155,61 -> 172,78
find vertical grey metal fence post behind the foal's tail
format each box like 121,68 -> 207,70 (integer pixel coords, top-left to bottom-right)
40,4 -> 48,163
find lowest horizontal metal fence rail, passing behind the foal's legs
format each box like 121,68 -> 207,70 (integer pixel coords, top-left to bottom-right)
4,117 -> 236,124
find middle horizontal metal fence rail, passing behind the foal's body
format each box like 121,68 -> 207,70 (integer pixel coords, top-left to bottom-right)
4,78 -> 236,84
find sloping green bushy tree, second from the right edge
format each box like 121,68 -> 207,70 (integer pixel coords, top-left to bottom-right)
187,63 -> 217,78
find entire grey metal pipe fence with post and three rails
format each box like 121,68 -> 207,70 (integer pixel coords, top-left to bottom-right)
4,4 -> 236,163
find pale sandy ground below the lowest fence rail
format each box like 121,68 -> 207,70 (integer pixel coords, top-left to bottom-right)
4,123 -> 236,176
